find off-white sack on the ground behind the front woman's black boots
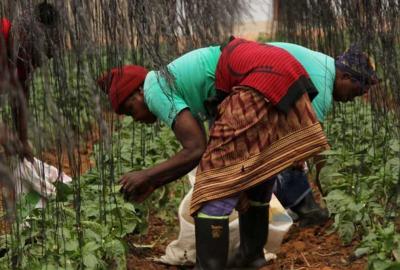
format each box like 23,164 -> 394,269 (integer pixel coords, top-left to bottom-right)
156,170 -> 293,265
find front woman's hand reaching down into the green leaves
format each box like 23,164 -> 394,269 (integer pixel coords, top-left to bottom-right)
119,171 -> 156,202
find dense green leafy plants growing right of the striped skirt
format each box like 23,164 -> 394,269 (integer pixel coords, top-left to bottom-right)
320,102 -> 400,269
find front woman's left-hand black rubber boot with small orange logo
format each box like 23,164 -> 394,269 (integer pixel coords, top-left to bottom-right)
194,218 -> 229,270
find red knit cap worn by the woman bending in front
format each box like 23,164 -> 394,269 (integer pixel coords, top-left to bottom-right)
97,65 -> 148,113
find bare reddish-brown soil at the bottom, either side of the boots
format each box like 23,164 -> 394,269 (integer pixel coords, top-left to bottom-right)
127,214 -> 366,270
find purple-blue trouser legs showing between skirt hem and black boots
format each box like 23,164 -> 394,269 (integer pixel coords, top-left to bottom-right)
200,177 -> 276,217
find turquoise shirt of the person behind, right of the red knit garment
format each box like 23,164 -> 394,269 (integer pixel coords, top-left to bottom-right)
268,42 -> 336,122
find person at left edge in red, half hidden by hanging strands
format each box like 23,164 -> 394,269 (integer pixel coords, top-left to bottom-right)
0,2 -> 59,161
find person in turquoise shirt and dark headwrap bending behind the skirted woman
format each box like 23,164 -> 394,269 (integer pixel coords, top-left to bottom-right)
269,42 -> 378,227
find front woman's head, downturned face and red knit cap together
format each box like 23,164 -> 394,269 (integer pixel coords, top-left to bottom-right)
97,65 -> 157,123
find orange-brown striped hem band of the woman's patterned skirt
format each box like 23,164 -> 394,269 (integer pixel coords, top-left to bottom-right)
191,122 -> 329,214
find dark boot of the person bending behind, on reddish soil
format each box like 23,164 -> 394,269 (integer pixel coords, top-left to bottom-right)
290,192 -> 329,227
